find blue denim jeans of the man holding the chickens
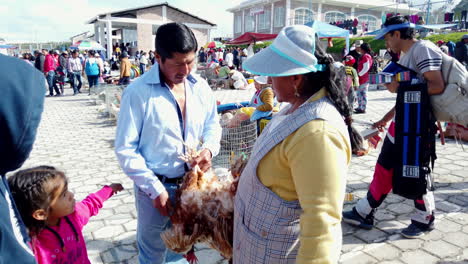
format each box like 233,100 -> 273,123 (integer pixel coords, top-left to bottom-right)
134,183 -> 188,264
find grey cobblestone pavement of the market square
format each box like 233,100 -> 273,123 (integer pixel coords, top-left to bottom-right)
17,85 -> 468,264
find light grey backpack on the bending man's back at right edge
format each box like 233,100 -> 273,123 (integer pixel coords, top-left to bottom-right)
431,54 -> 468,127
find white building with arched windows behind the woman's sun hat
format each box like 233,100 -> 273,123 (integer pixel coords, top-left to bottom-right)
227,0 -> 420,37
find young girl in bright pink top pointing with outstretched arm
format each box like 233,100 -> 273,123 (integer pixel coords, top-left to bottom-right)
8,166 -> 123,264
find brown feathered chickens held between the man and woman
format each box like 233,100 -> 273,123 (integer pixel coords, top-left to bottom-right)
161,147 -> 246,259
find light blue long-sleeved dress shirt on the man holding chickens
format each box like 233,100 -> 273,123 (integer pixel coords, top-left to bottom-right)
115,64 -> 221,199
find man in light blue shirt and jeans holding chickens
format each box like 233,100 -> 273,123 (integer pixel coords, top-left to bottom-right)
115,23 -> 221,264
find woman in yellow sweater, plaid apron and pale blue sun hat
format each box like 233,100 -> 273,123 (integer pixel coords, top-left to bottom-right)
233,25 -> 362,264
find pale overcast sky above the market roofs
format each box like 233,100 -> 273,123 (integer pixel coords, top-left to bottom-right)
0,0 -> 459,43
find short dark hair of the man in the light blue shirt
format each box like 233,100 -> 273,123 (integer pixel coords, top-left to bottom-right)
155,23 -> 198,62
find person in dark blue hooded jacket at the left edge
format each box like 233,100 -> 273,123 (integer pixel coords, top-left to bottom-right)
0,54 -> 45,264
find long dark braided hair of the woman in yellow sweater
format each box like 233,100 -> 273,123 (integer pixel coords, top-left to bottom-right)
298,36 -> 363,152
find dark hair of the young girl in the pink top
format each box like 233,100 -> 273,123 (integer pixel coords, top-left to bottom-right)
8,166 -> 67,235
